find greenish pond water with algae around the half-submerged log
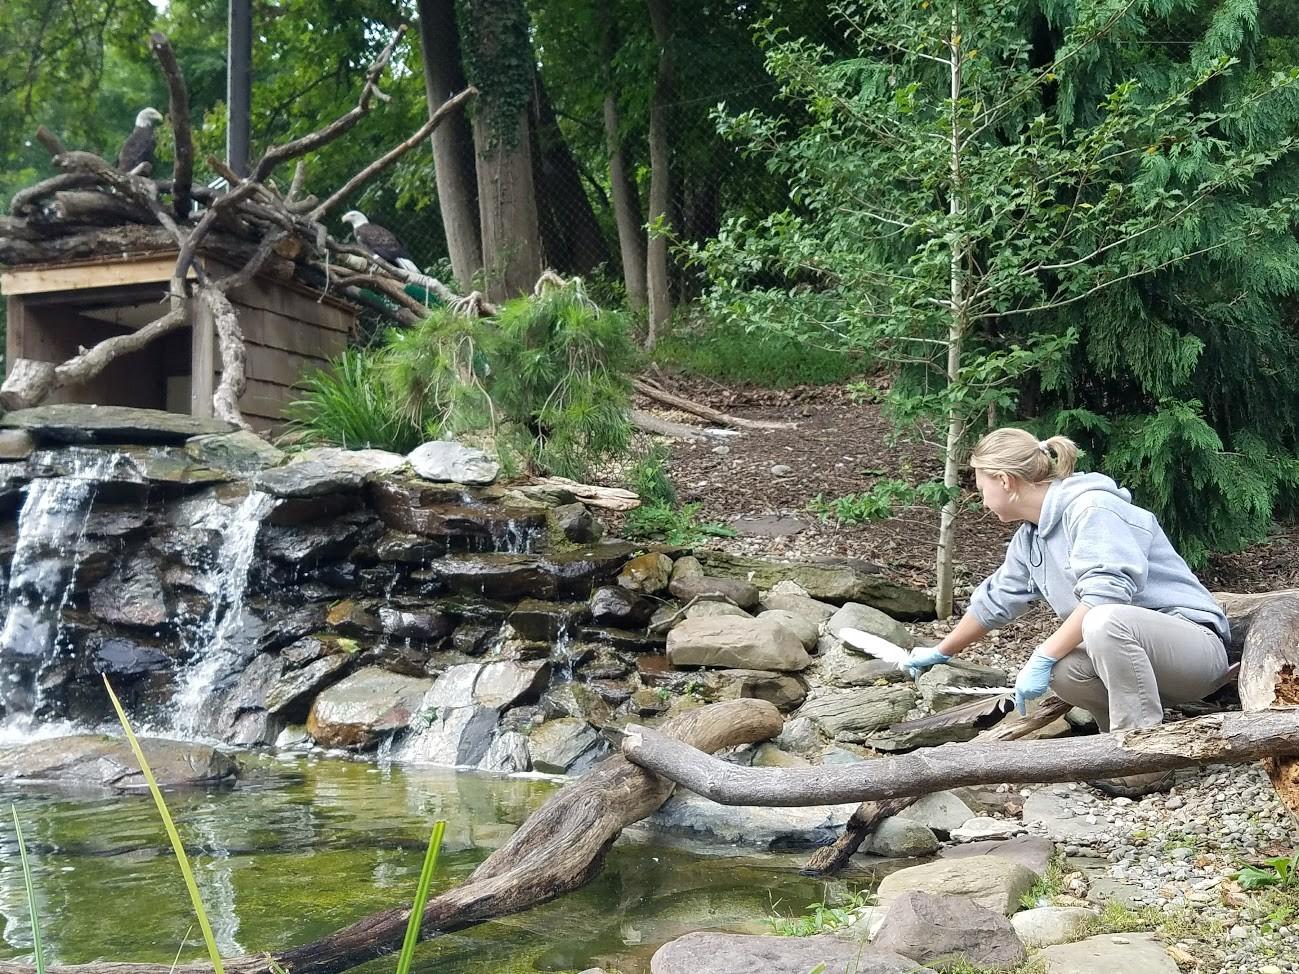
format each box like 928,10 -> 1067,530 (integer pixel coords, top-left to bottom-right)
0,756 -> 822,974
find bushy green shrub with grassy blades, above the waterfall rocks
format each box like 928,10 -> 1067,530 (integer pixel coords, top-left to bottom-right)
291,281 -> 638,479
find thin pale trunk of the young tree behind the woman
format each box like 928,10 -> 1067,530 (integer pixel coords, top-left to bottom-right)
934,9 -> 969,619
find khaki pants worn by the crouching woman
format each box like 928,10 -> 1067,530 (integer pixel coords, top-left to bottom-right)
1051,604 -> 1228,730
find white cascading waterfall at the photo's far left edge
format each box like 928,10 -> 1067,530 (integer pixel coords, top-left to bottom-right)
0,448 -> 126,722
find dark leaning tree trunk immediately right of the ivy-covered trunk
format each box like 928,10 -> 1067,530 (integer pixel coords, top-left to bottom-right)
533,74 -> 609,274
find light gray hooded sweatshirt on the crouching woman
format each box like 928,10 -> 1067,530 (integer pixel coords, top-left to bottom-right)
970,474 -> 1230,642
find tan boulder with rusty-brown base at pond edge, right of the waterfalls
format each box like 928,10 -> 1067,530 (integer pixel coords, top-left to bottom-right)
307,666 -> 433,748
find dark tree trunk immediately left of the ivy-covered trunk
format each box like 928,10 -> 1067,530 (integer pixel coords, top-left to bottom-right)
420,0 -> 483,291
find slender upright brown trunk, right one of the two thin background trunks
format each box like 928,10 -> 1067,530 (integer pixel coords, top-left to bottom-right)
646,0 -> 672,348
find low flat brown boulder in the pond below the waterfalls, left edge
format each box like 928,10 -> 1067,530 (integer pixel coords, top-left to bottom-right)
0,734 -> 238,791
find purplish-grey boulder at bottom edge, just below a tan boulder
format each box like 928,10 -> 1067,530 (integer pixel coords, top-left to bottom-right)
873,891 -> 1028,970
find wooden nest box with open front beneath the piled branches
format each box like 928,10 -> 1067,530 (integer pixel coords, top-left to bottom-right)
0,252 -> 357,430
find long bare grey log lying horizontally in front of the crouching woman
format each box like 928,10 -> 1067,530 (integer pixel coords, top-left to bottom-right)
622,709 -> 1299,808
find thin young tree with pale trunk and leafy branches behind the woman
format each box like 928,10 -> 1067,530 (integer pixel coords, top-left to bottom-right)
696,0 -> 1299,617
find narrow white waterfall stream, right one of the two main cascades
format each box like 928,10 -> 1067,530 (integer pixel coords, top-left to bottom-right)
171,491 -> 275,735
